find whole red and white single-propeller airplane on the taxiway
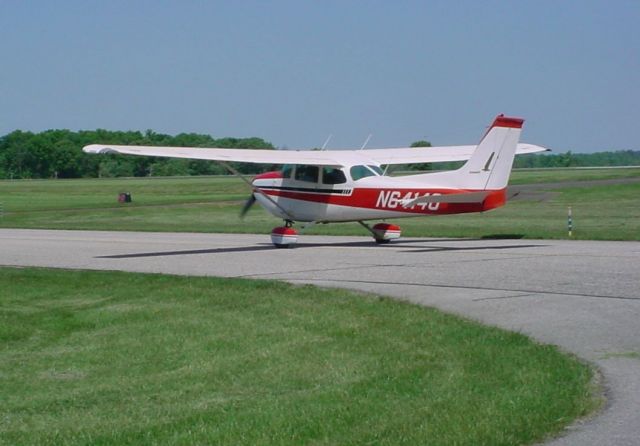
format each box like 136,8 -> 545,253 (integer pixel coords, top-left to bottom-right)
83,114 -> 548,248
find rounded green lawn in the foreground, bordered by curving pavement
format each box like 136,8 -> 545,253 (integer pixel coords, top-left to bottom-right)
0,269 -> 597,445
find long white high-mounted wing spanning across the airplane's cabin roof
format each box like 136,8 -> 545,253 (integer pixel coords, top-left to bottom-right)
82,144 -> 549,167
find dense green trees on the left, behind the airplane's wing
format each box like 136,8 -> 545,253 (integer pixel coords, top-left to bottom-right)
0,129 -> 274,178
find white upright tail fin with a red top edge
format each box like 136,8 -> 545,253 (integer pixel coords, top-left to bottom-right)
455,115 -> 524,190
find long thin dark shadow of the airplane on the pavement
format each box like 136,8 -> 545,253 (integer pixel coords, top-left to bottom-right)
96,239 -> 545,259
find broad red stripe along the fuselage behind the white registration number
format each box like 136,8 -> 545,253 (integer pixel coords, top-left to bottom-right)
261,188 -> 507,214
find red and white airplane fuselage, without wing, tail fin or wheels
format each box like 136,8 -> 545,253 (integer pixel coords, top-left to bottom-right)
252,166 -> 506,222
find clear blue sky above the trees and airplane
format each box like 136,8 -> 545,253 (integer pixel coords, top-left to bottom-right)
0,0 -> 640,152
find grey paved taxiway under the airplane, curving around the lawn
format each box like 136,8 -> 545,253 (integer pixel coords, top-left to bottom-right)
0,229 -> 640,445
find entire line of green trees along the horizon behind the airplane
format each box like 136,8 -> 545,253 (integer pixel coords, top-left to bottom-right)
0,130 -> 640,179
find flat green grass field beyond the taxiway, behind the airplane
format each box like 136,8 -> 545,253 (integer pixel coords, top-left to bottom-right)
0,168 -> 640,240
